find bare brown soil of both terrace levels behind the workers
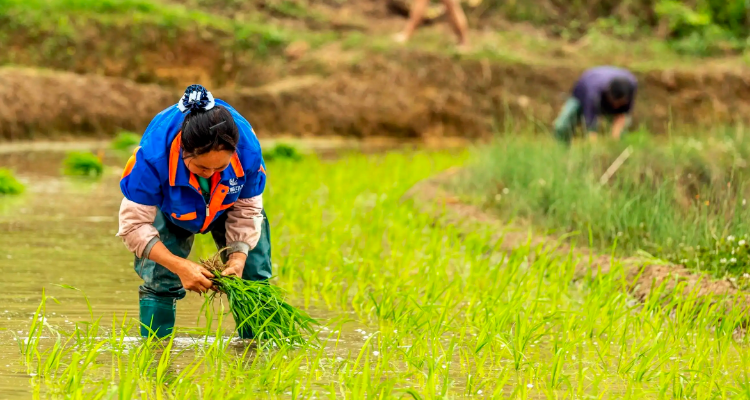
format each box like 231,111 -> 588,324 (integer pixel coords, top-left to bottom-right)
0,0 -> 750,139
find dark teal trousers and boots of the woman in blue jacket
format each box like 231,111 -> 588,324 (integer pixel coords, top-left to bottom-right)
135,211 -> 271,338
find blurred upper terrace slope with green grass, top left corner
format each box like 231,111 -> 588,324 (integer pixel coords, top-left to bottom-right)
0,0 -> 312,85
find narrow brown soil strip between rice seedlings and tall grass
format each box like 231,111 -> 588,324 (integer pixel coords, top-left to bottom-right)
404,168 -> 750,318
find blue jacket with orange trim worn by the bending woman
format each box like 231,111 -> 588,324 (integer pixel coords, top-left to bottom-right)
120,99 -> 266,233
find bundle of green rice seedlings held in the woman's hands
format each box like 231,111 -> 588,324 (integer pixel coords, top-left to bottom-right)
200,249 -> 318,347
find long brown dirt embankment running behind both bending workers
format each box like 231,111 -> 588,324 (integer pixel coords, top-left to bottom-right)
0,50 -> 750,139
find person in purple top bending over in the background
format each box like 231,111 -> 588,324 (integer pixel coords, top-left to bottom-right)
554,66 -> 638,142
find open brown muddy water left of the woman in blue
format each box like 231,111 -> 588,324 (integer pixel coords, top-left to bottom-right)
0,141 -> 440,399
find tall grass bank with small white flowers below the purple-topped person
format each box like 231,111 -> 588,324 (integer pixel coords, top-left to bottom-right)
456,128 -> 750,276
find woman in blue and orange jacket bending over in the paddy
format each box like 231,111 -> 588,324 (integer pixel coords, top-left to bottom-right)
117,85 -> 271,339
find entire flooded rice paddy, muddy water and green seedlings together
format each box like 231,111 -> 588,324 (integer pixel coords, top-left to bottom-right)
0,143 -> 750,399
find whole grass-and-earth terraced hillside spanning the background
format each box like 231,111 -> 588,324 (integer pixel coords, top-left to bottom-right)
0,0 -> 750,140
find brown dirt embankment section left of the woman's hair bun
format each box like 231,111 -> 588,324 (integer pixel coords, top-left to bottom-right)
0,68 -> 176,139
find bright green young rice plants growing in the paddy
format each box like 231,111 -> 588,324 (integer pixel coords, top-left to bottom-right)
18,153 -> 750,399
